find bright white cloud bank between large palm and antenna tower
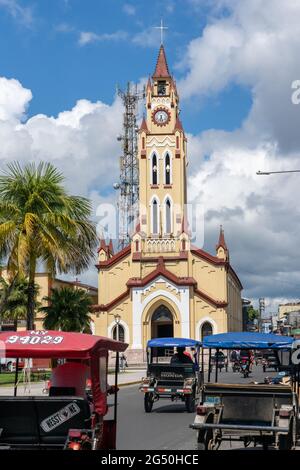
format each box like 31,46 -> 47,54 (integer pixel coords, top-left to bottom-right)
0,78 -> 123,200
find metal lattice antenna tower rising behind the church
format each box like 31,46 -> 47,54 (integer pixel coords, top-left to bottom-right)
114,83 -> 145,250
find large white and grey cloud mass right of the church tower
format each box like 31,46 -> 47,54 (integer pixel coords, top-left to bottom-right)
178,0 -> 300,308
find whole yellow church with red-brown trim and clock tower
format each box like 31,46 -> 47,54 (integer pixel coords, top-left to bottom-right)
92,46 -> 242,362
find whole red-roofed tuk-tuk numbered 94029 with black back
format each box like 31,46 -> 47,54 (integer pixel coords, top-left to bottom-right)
0,330 -> 128,450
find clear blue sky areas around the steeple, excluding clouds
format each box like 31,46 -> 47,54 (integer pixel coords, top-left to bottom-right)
0,0 -> 251,133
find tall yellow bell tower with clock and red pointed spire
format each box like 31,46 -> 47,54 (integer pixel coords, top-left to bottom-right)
138,45 -> 187,239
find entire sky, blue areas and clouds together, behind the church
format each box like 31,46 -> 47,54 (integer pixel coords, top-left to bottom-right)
0,0 -> 300,310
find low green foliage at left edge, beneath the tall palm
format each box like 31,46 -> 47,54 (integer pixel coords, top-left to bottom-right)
0,277 -> 39,330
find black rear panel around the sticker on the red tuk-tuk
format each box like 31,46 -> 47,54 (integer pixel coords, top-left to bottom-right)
0,396 -> 91,447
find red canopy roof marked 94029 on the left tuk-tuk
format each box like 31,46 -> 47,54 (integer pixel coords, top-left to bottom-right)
0,330 -> 128,359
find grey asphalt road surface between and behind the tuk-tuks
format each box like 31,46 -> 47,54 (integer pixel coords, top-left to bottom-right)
111,367 -> 274,450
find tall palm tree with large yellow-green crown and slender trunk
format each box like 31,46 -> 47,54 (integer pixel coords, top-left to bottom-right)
0,162 -> 97,329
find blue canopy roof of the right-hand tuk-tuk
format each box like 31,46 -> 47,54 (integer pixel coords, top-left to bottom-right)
202,332 -> 293,349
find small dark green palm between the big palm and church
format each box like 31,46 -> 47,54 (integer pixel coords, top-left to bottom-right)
39,287 -> 92,333
